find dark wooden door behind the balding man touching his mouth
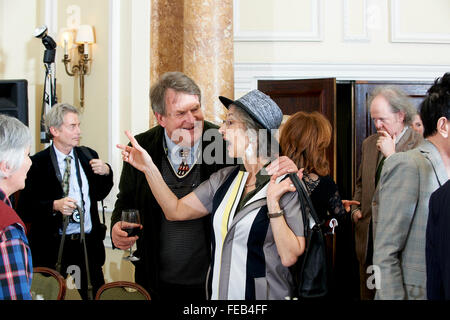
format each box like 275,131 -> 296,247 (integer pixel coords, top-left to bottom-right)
352,81 -> 432,191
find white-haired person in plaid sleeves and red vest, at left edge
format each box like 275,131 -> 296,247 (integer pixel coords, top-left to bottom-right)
0,115 -> 33,300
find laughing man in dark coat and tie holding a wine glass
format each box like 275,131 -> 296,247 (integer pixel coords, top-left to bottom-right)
111,72 -> 234,300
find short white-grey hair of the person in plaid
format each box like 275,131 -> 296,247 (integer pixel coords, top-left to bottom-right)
0,114 -> 31,179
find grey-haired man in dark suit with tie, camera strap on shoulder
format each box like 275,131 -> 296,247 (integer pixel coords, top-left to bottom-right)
18,104 -> 113,299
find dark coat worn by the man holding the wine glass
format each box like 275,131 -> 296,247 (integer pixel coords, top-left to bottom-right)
111,121 -> 230,294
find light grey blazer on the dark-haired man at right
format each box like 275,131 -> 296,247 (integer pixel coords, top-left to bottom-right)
373,140 -> 448,300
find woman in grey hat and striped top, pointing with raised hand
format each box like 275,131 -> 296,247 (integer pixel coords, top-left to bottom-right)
118,90 -> 305,300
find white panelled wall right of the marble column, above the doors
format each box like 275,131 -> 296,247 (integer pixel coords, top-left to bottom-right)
234,0 -> 450,97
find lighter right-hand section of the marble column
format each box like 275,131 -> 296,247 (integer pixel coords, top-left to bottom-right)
183,0 -> 234,123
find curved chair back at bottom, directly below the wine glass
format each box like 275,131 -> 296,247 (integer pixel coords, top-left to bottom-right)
95,281 -> 151,300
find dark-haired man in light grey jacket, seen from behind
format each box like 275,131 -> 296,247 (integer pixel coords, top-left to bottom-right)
373,73 -> 450,300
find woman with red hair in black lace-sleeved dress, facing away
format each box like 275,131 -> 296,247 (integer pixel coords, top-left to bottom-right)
280,111 -> 358,299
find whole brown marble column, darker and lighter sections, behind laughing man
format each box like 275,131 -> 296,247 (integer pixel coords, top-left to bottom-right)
151,0 -> 234,124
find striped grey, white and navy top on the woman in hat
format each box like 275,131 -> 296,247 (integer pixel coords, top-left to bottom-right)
194,167 -> 303,300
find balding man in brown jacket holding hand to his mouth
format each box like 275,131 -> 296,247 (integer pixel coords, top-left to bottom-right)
352,86 -> 423,300
